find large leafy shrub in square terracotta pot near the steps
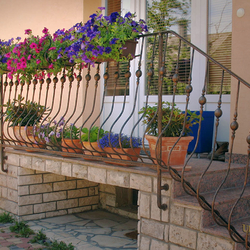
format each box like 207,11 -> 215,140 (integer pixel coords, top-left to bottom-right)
139,102 -> 199,166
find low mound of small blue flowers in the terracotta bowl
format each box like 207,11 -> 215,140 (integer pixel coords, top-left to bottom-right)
99,133 -> 142,148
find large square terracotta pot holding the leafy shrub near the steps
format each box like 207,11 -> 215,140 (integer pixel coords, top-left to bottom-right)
145,135 -> 194,166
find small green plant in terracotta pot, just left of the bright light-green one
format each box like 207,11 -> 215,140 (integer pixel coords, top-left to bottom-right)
62,124 -> 82,156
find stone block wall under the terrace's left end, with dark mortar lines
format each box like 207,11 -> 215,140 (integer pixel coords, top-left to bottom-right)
0,156 -> 99,220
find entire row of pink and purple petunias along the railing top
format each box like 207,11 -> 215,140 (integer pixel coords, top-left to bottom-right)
0,7 -> 147,81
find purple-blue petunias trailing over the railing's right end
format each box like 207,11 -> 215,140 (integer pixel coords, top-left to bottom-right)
66,7 -> 147,63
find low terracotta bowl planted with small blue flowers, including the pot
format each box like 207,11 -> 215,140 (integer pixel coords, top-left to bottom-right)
99,133 -> 142,166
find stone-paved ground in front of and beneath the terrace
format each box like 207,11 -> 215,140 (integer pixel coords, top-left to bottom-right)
0,210 -> 137,250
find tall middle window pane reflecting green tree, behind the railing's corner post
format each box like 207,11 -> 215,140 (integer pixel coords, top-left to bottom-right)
146,0 -> 191,95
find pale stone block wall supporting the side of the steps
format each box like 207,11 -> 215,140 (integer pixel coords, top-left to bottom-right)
138,189 -> 235,250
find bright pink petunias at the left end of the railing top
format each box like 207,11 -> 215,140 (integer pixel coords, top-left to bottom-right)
0,28 -> 76,80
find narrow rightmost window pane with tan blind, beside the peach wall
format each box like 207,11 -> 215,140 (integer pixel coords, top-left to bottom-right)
207,0 -> 232,94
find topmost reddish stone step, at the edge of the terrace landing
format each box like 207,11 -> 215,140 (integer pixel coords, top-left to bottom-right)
173,158 -> 250,197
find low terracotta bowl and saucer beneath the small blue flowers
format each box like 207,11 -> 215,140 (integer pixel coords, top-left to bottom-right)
101,147 -> 141,167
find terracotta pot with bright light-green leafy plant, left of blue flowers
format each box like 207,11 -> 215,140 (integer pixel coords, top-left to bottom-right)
81,126 -> 106,156
